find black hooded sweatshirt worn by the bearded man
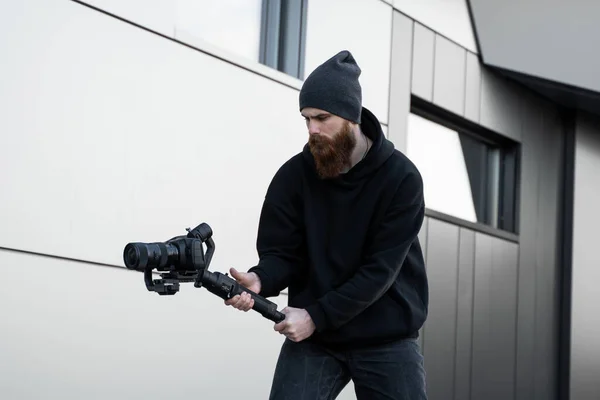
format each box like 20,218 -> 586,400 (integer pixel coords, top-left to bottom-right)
250,108 -> 428,347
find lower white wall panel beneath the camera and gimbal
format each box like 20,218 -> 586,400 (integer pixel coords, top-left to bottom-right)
0,250 -> 284,400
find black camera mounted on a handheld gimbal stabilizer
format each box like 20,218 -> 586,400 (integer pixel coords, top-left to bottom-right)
123,223 -> 285,322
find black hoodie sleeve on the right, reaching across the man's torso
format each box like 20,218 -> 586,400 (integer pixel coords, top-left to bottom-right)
306,172 -> 425,332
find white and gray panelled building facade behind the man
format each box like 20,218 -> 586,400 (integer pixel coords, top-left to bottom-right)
0,0 -> 600,400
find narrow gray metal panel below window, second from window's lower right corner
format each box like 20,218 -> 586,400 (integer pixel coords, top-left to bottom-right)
471,233 -> 494,400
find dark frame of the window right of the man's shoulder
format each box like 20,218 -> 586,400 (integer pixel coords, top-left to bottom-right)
406,95 -> 521,242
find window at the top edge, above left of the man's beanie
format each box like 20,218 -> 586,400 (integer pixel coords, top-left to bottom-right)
175,0 -> 308,79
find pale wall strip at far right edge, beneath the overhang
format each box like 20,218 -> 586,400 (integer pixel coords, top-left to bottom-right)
571,114 -> 600,400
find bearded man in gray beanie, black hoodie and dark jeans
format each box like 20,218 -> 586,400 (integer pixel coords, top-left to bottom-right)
226,51 -> 429,400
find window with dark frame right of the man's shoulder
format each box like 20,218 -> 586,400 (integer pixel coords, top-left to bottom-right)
406,104 -> 517,233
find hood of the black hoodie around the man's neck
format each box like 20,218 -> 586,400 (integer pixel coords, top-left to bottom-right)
302,107 -> 395,183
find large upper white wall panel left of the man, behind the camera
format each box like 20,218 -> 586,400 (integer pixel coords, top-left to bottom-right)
0,0 -> 306,268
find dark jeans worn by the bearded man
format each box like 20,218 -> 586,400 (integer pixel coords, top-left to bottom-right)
269,339 -> 427,400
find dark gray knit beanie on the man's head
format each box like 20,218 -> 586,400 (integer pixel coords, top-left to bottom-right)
300,50 -> 362,123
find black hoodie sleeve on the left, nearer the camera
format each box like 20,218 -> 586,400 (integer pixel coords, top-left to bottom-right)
248,159 -> 303,297
